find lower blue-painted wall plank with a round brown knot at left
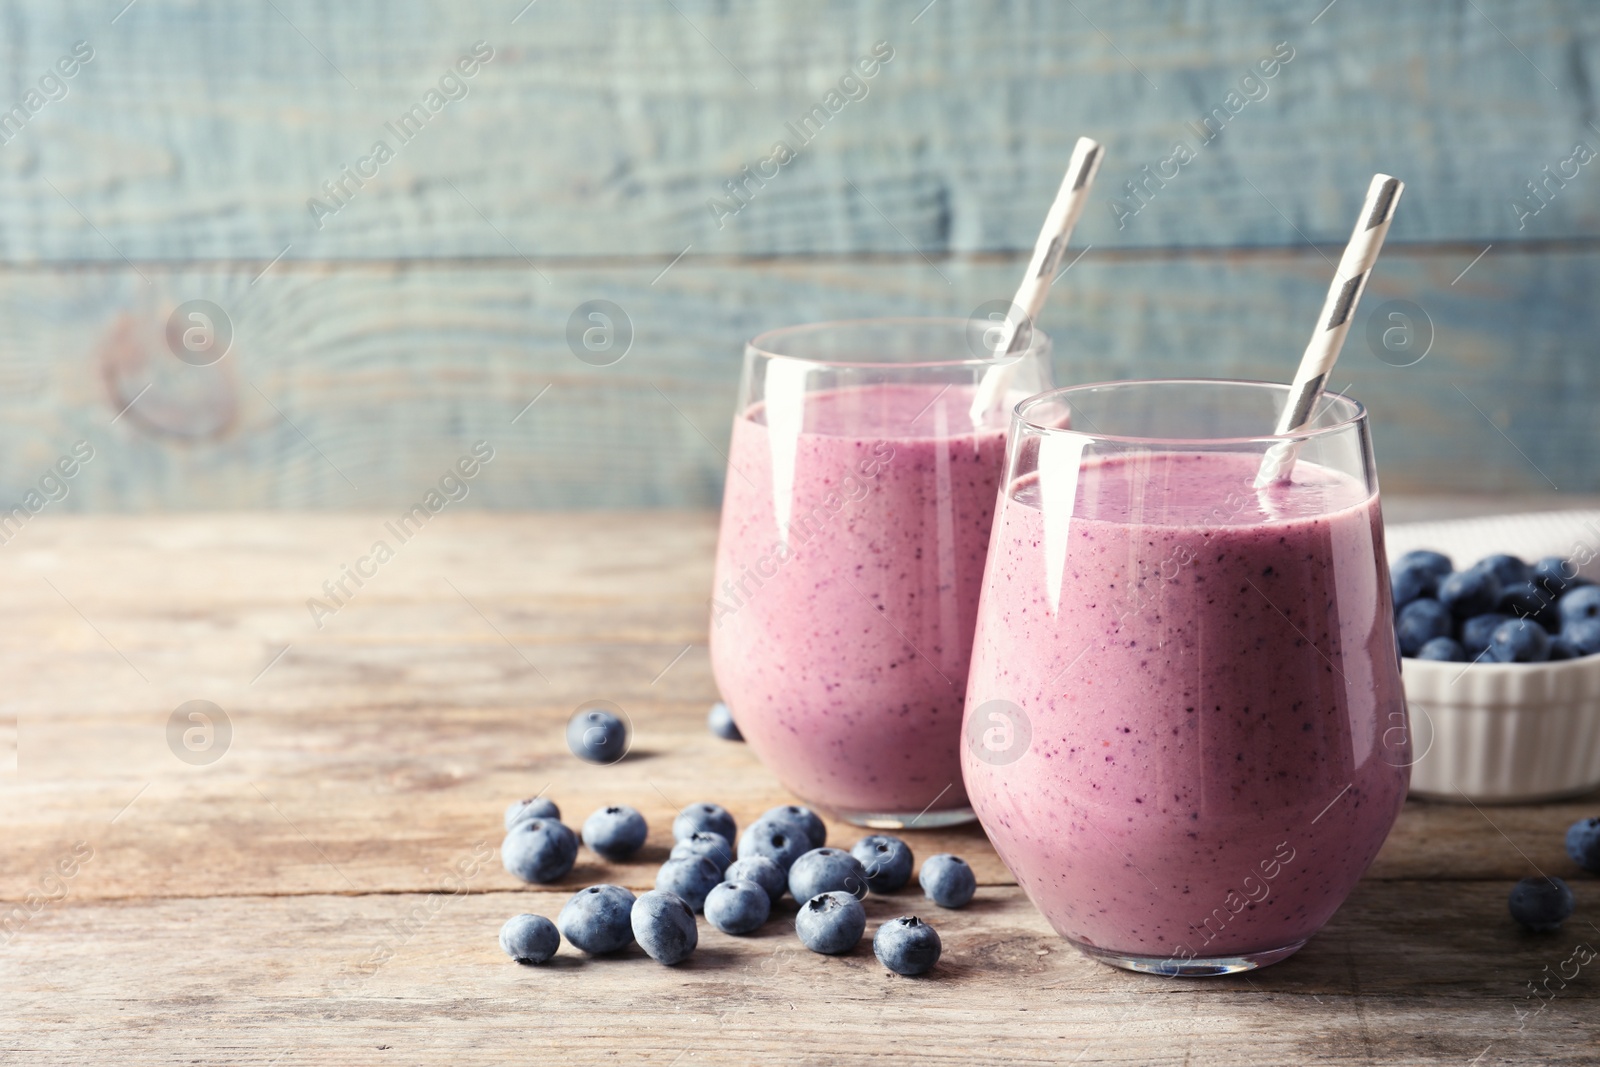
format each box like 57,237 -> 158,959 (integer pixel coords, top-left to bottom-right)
0,248 -> 1600,508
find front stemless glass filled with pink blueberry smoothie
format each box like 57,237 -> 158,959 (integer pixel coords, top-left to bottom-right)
962,381 -> 1411,974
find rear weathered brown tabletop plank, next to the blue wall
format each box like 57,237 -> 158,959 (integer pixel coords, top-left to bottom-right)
0,512 -> 1600,901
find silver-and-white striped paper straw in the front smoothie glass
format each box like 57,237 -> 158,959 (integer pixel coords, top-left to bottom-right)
1256,174 -> 1405,490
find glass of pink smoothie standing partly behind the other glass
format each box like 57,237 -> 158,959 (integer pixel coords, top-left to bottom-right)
710,318 -> 1051,827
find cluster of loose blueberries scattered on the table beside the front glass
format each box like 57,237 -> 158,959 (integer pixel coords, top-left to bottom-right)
499,797 -> 978,974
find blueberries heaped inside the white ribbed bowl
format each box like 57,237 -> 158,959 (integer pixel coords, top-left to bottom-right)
1389,549 -> 1600,664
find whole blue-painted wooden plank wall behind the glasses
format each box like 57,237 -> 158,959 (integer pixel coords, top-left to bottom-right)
0,0 -> 1600,510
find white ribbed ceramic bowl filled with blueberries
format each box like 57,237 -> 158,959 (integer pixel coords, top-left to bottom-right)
1389,549 -> 1600,803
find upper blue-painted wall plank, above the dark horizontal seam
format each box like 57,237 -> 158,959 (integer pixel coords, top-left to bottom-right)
0,0 -> 1600,264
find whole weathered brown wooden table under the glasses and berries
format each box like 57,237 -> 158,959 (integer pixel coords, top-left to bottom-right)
0,509 -> 1600,1067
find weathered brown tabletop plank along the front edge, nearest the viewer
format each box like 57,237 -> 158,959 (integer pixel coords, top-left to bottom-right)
0,883 -> 1600,1065
